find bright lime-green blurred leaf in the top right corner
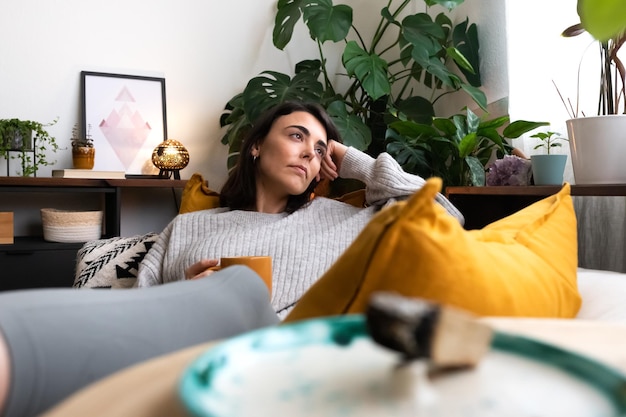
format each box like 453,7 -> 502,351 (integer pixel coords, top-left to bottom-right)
578,0 -> 626,41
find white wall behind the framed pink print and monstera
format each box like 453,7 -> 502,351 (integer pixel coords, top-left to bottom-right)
0,0 -> 508,234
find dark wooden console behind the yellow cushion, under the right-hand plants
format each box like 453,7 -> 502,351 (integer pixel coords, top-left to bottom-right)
446,184 -> 626,229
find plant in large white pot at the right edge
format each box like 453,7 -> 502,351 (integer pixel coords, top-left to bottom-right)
563,0 -> 626,184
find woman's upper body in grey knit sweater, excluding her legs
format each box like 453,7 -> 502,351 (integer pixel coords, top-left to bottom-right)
137,102 -> 462,318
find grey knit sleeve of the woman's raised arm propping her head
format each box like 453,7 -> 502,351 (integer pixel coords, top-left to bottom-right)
339,147 -> 465,224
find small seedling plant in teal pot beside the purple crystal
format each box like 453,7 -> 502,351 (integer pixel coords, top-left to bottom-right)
530,132 -> 569,185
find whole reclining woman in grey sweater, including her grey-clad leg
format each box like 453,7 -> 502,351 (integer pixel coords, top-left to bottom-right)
0,103 -> 462,417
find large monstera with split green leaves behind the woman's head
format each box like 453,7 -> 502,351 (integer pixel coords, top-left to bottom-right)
220,0 -> 540,185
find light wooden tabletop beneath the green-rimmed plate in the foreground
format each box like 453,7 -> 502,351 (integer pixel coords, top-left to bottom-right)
44,318 -> 626,417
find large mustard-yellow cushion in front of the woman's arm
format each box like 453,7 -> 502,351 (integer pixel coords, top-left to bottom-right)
286,178 -> 581,322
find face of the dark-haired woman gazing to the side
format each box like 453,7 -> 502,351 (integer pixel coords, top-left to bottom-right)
252,111 -> 328,199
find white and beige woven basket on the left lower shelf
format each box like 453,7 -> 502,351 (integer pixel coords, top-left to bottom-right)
41,208 -> 102,243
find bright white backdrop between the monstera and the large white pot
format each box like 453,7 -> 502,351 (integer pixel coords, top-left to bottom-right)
506,0 -> 599,183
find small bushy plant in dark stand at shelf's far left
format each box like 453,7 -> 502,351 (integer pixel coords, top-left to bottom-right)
0,119 -> 59,177
